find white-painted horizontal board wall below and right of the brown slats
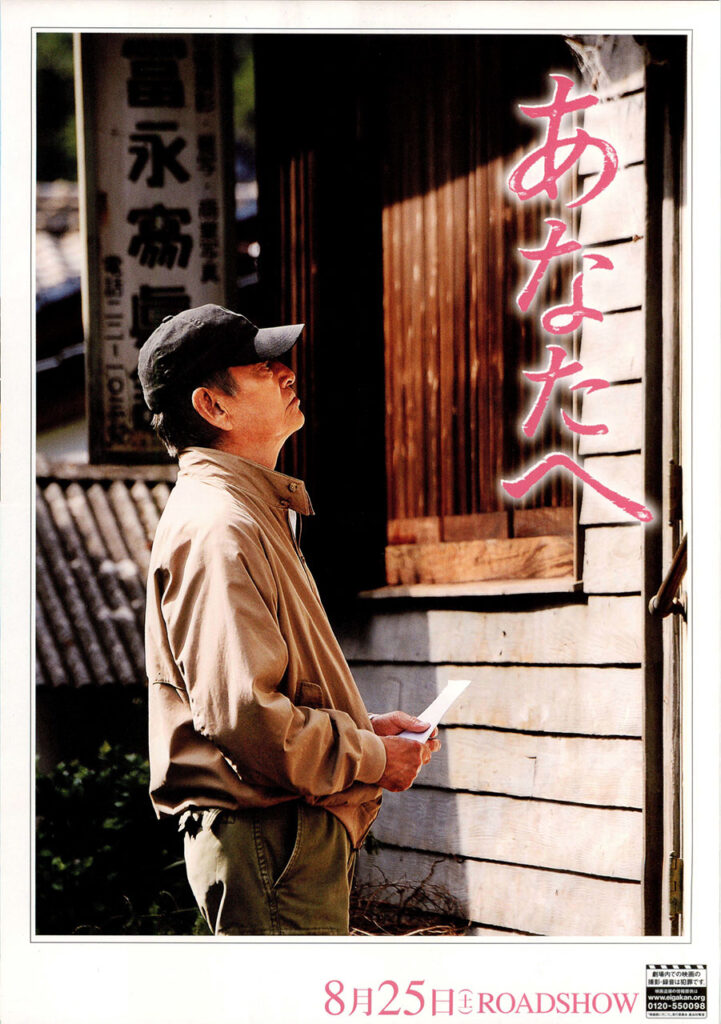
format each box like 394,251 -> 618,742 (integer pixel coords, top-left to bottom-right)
344,44 -> 646,936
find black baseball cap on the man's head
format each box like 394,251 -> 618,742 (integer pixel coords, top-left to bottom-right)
137,303 -> 305,413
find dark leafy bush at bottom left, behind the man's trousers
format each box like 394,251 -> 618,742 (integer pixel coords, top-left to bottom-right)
36,743 -> 207,935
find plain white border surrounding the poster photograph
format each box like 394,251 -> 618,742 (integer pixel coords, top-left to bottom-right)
0,0 -> 721,1024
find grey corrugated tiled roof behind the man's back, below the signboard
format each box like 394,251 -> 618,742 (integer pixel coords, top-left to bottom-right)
36,459 -> 175,686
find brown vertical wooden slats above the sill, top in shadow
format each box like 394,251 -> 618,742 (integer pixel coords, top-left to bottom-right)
382,37 -> 572,520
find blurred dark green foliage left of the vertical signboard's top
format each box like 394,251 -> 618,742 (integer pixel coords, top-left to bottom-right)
37,32 -> 78,181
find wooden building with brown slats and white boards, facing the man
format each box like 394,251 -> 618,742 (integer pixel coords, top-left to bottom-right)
255,35 -> 685,935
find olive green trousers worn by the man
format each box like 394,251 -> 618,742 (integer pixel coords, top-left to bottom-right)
180,800 -> 355,935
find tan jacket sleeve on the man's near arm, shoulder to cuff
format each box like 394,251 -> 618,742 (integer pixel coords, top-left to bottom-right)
162,523 -> 385,801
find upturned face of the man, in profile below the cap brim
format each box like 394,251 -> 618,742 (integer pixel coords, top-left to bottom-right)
217,359 -> 305,451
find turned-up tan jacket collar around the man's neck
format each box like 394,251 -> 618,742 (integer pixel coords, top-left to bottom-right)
178,447 -> 313,515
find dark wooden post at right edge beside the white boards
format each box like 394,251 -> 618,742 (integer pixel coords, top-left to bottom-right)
643,37 -> 685,935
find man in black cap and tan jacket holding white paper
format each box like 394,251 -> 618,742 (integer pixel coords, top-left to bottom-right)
138,305 -> 439,935
